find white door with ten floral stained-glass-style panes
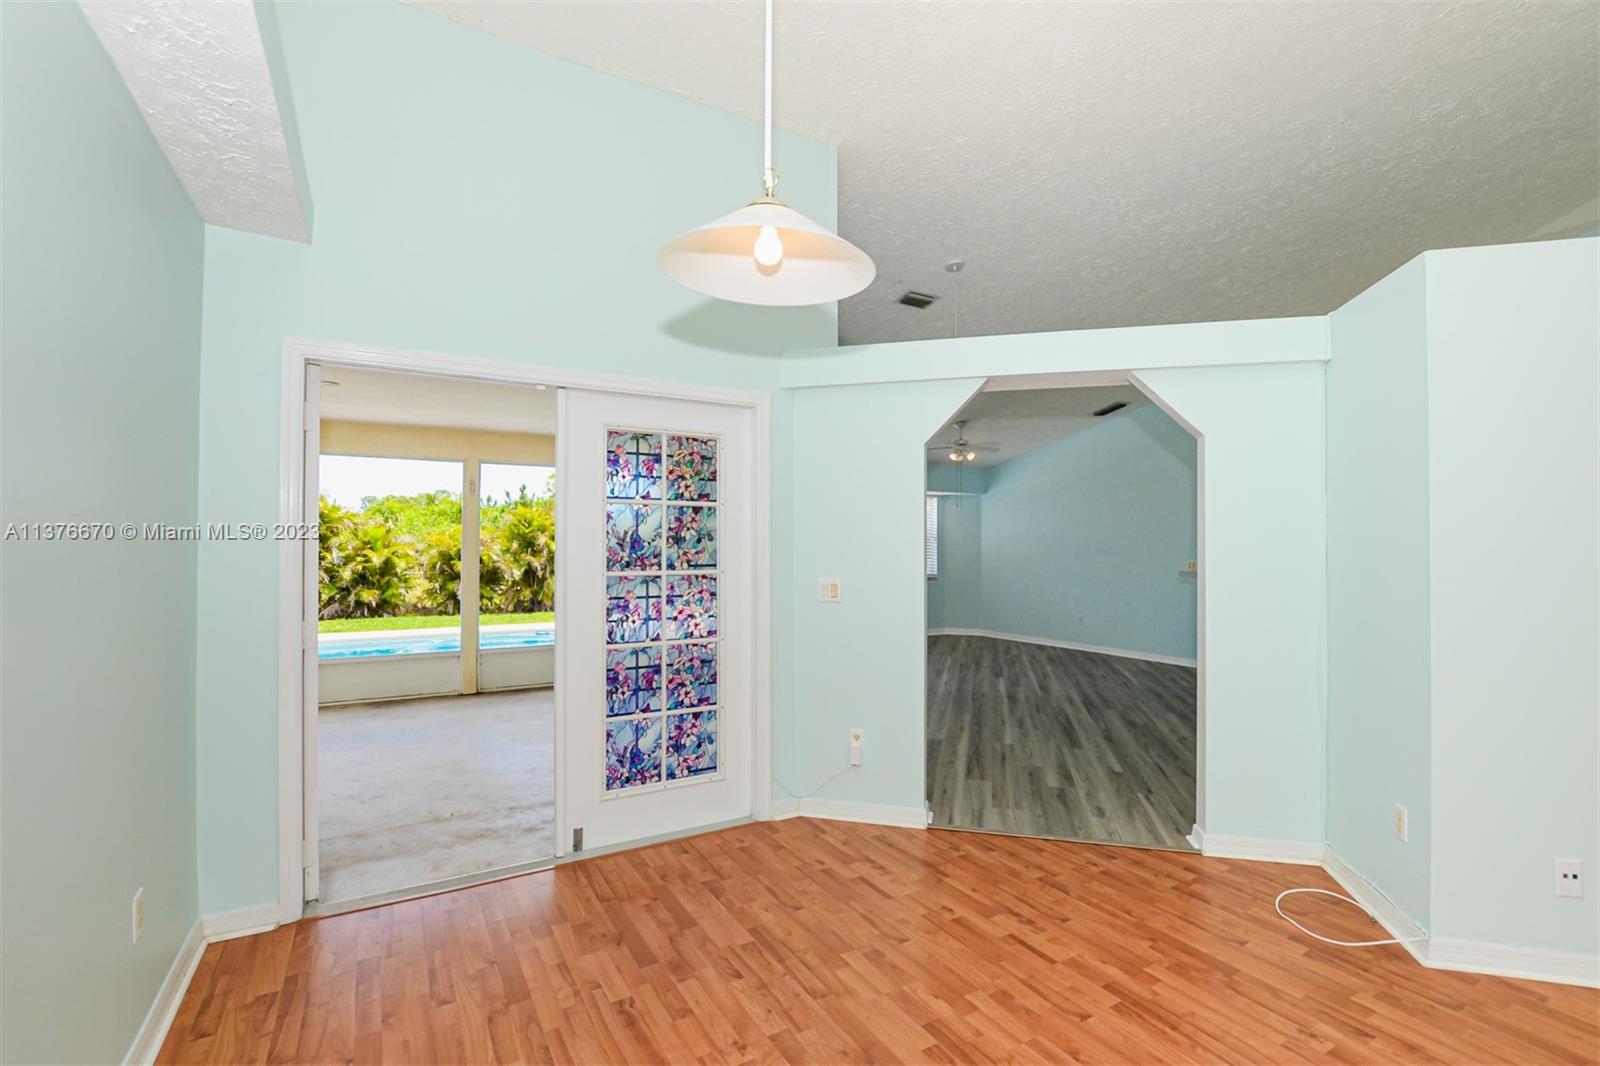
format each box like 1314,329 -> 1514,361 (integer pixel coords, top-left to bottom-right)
557,389 -> 757,852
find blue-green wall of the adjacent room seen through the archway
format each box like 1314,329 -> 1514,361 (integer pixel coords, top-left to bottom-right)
942,403 -> 1197,659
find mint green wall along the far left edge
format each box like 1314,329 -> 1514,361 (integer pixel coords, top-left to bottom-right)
0,3 -> 203,1063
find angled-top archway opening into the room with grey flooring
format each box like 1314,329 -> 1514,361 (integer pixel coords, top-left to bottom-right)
925,383 -> 1198,850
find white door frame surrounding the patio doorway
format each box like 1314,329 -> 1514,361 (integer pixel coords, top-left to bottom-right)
278,338 -> 773,922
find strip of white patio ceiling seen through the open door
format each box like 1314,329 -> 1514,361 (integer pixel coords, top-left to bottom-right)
322,367 -> 555,434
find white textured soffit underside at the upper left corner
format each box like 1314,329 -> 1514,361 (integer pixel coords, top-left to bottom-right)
78,0 -> 309,240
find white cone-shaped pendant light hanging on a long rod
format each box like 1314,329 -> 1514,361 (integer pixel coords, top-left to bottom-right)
656,0 -> 878,307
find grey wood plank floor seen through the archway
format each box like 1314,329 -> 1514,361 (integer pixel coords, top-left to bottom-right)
928,637 -> 1195,852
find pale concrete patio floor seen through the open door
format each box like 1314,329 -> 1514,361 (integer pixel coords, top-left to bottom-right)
317,688 -> 555,903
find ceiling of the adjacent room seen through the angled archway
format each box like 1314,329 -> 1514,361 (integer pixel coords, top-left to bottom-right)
928,384 -> 1149,466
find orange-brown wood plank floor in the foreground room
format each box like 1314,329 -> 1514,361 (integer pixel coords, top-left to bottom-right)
152,820 -> 1600,1063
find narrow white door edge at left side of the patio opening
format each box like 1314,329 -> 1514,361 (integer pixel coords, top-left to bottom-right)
299,363 -> 322,900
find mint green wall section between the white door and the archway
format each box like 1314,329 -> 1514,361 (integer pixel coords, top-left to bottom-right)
773,379 -> 979,810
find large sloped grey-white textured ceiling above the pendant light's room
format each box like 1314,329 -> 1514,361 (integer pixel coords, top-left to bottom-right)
418,0 -> 1600,343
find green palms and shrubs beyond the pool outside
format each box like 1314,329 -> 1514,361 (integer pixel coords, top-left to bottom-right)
318,487 -> 555,629
